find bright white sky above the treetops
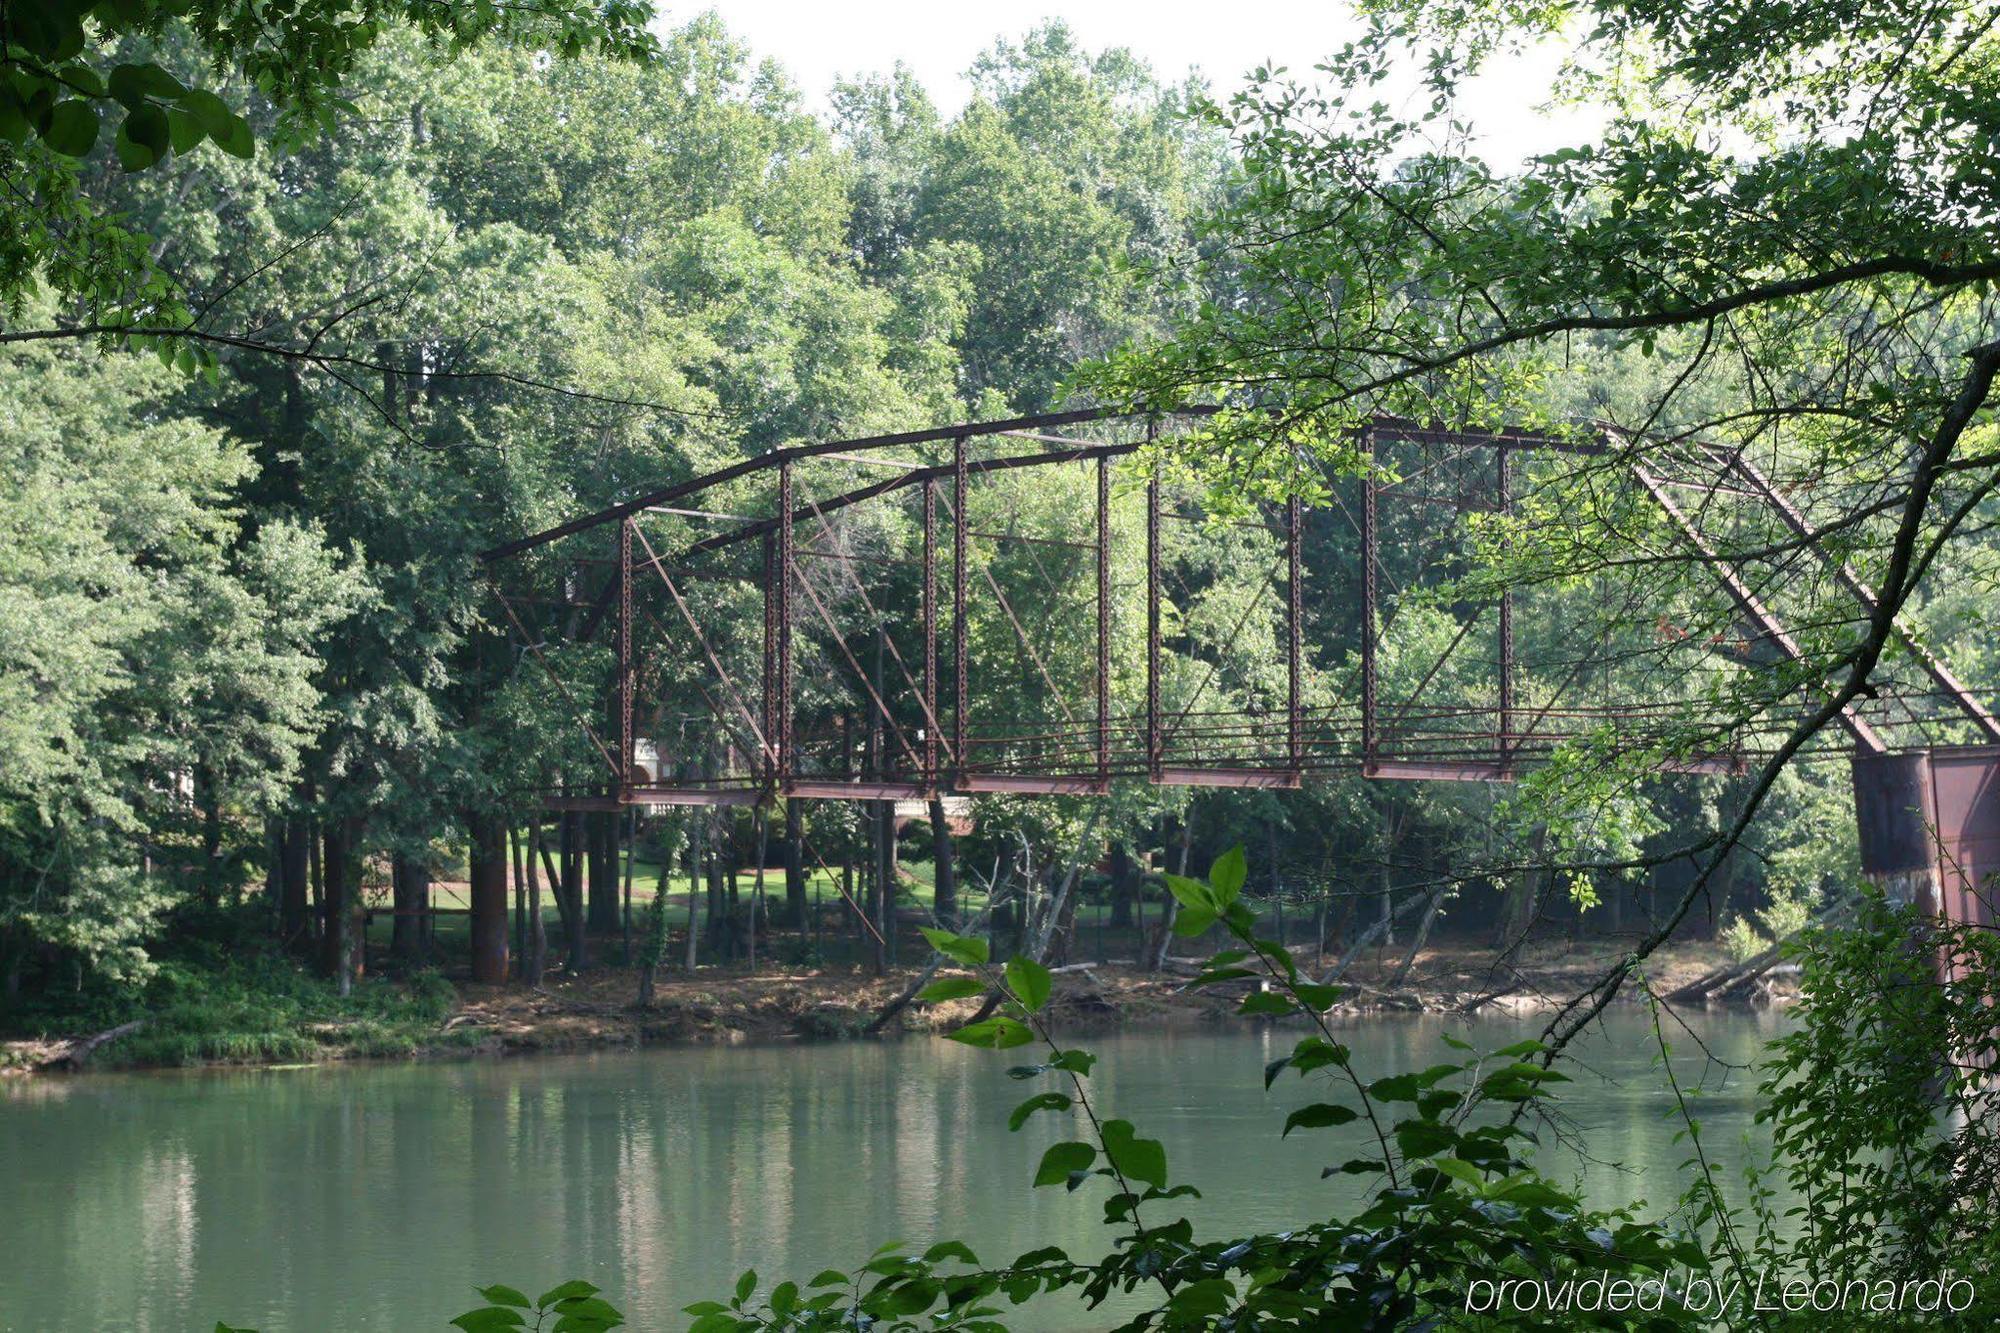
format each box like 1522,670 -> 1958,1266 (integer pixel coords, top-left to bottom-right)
696,0 -> 1600,162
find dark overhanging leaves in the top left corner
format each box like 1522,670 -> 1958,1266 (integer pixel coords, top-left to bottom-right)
0,0 -> 656,334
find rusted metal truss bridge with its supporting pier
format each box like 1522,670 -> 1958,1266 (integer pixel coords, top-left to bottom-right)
482,410 -> 2000,944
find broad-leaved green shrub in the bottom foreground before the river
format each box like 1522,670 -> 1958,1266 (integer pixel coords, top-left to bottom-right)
688,849 -> 1708,1333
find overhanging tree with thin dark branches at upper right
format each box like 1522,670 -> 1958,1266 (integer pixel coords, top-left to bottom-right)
1084,0 -> 2000,1040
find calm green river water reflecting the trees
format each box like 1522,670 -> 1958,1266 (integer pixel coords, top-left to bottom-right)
0,1009 -> 1782,1333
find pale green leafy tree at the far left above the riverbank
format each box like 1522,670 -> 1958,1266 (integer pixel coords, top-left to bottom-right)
0,332 -> 370,999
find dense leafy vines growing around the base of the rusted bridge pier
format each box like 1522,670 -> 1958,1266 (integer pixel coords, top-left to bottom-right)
1750,893 -> 2000,1327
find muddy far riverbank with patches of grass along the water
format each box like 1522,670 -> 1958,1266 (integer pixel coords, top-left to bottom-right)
0,928 -> 1760,1073
